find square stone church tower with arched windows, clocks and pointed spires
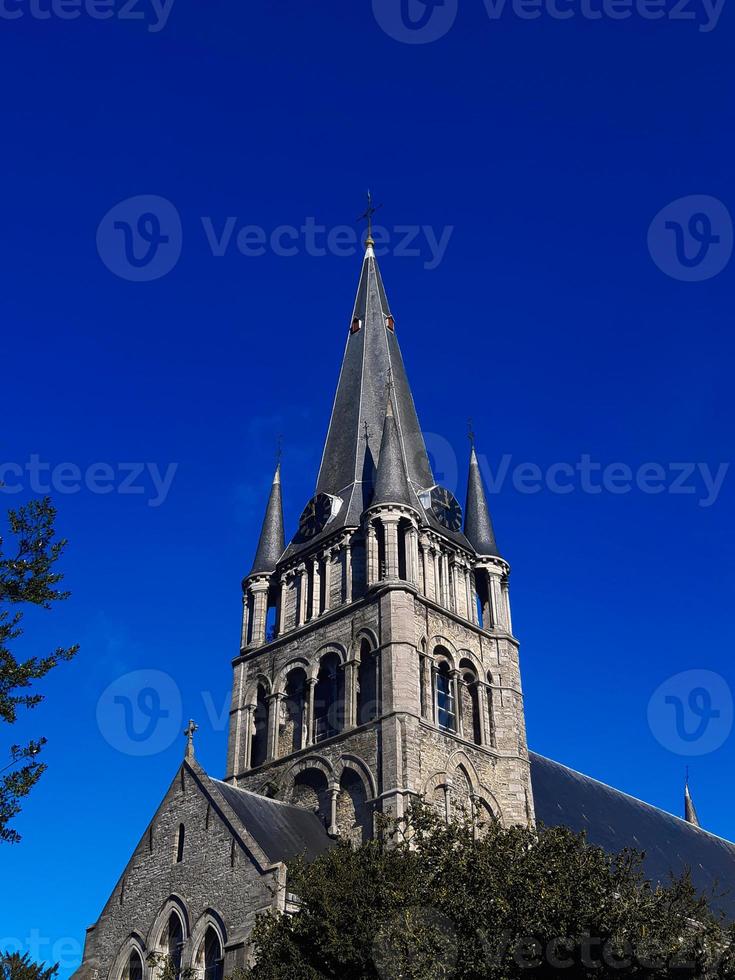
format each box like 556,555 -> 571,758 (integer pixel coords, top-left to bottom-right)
227,238 -> 534,840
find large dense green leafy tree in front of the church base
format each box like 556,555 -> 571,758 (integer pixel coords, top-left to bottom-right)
246,805 -> 735,980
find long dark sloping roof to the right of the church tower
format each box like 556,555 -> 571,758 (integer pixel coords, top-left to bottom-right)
530,753 -> 735,920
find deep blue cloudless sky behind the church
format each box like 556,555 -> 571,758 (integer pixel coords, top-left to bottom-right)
0,0 -> 735,975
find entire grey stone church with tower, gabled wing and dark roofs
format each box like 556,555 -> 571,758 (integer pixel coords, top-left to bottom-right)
72,238 -> 735,980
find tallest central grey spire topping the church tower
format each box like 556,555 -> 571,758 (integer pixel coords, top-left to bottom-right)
317,241 -> 434,525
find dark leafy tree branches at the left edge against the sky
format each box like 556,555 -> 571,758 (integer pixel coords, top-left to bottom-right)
0,497 -> 77,842
